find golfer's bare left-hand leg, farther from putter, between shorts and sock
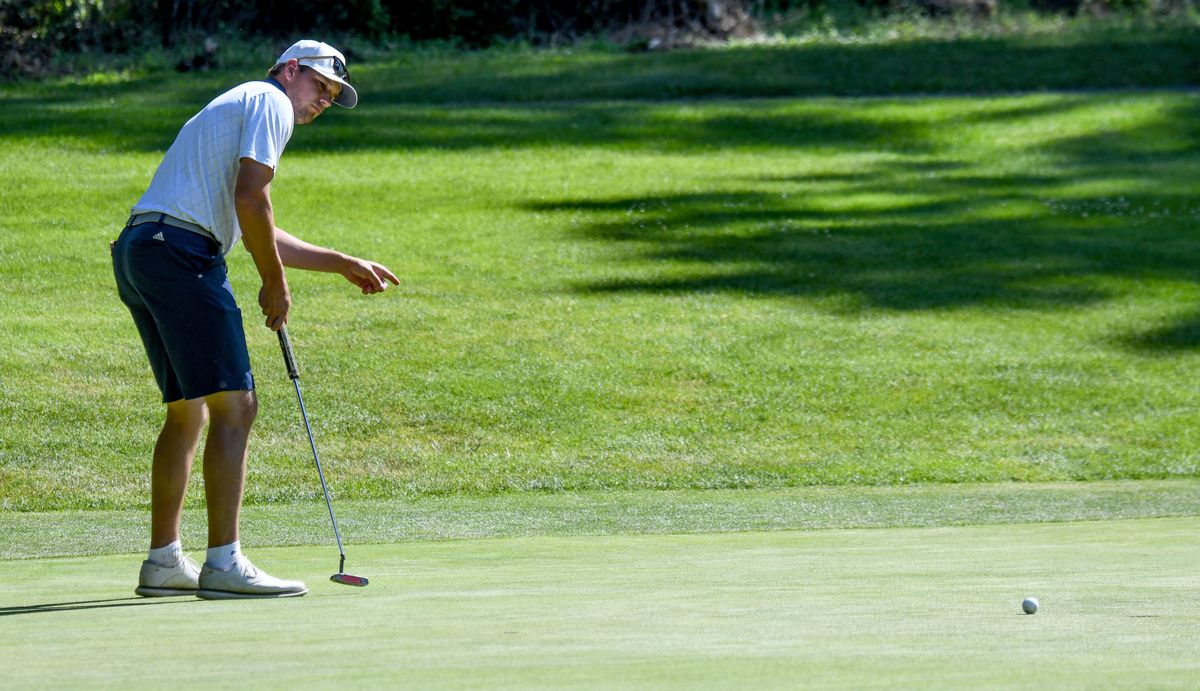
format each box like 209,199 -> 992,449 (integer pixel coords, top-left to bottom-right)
150,399 -> 208,547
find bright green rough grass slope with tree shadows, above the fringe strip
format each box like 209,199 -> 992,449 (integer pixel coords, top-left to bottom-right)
0,31 -> 1200,511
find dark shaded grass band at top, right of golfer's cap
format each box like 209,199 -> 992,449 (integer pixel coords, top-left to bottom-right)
357,30 -> 1200,103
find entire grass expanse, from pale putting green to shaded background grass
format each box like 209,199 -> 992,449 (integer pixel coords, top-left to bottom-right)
0,29 -> 1200,689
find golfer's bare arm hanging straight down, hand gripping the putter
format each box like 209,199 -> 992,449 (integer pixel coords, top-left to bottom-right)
234,158 -> 292,331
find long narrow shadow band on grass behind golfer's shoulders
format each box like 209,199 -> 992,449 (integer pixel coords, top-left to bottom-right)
0,82 -> 1088,154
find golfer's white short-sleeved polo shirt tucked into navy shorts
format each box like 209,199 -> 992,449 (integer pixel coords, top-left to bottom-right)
132,82 -> 295,254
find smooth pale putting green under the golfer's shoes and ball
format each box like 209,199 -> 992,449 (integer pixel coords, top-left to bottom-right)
0,518 -> 1200,689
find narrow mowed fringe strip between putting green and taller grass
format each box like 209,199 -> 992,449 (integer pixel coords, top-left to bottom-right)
0,480 -> 1200,563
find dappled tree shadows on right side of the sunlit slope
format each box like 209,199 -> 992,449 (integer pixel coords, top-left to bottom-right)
524,95 -> 1200,353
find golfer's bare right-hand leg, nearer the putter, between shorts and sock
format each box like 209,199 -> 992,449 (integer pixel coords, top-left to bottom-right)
204,391 -> 258,547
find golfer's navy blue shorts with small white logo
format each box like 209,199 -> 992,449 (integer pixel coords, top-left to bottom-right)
113,223 -> 254,403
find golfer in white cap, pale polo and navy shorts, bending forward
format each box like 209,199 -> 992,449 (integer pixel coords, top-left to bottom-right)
113,41 -> 398,599
